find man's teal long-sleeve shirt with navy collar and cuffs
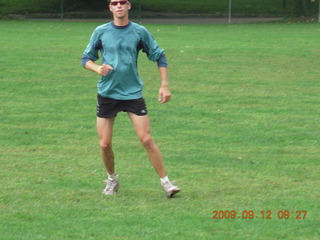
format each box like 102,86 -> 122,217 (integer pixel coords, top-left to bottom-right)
82,22 -> 167,100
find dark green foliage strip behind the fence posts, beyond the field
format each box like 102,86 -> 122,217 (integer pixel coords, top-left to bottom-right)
0,0 -> 318,16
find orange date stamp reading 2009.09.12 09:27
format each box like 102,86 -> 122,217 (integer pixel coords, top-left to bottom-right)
212,210 -> 308,220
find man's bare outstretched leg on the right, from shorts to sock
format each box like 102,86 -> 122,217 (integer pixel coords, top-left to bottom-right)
129,112 -> 166,178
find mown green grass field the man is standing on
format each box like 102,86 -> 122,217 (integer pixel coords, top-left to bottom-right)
0,21 -> 320,240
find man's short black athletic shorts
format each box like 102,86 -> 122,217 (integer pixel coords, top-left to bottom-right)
97,94 -> 148,118
